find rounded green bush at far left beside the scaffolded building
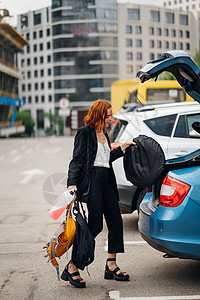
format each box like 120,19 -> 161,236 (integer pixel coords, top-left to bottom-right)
15,110 -> 35,136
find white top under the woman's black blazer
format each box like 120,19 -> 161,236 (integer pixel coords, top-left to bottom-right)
94,140 -> 110,168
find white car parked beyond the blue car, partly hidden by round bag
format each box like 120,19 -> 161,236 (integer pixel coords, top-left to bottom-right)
109,101 -> 200,213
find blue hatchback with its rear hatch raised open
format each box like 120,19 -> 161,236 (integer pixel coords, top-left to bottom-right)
137,51 -> 200,260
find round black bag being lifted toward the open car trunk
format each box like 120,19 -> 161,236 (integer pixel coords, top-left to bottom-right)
124,135 -> 165,188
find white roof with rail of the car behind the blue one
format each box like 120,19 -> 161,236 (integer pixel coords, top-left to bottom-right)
114,101 -> 200,121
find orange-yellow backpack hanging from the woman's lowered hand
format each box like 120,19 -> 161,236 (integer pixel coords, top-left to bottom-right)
44,198 -> 76,280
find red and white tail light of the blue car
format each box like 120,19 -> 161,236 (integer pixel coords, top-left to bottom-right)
160,175 -> 190,207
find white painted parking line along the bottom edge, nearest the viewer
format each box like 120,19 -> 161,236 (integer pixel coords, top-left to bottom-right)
109,291 -> 200,300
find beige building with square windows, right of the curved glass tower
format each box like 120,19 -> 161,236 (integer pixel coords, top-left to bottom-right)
118,3 -> 199,79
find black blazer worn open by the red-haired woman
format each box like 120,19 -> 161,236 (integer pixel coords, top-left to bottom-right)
67,126 -> 123,202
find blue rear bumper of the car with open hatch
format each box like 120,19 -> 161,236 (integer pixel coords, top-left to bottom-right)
138,201 -> 200,260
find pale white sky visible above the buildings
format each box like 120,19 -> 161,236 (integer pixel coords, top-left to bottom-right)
0,0 -> 161,26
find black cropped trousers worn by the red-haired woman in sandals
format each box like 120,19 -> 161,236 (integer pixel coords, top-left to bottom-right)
87,167 -> 124,253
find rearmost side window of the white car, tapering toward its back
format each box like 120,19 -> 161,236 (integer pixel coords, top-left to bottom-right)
144,114 -> 177,136
